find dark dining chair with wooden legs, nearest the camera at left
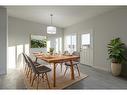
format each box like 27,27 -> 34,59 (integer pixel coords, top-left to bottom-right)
27,56 -> 51,89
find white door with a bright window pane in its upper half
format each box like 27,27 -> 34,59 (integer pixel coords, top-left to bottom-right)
80,32 -> 93,66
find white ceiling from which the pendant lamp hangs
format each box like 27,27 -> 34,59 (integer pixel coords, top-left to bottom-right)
6,6 -> 117,28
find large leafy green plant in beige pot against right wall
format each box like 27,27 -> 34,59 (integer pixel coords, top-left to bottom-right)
108,38 -> 125,76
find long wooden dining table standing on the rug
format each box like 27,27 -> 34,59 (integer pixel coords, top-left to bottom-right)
33,53 -> 79,87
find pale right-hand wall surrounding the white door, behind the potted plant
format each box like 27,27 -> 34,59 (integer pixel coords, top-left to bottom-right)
64,7 -> 127,71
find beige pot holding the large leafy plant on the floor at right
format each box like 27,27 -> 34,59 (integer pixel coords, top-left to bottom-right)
111,63 -> 122,76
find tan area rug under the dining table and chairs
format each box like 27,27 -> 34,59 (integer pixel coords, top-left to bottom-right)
24,65 -> 88,89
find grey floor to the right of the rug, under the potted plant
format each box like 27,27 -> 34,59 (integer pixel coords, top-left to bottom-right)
67,65 -> 127,89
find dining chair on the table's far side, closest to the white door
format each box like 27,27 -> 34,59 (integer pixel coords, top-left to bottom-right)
64,51 -> 80,76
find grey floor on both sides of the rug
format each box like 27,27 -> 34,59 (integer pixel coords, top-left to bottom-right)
0,65 -> 127,89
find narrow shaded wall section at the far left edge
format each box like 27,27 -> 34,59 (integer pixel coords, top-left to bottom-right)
0,7 -> 7,74
